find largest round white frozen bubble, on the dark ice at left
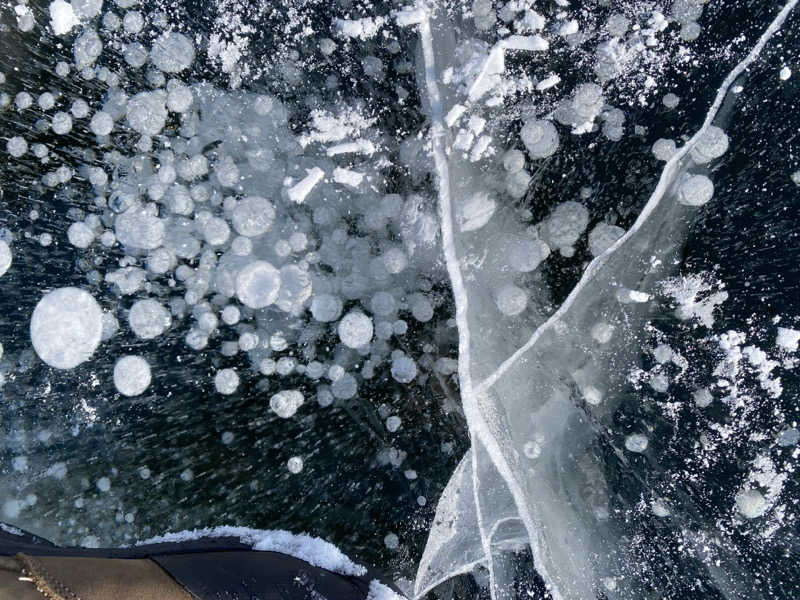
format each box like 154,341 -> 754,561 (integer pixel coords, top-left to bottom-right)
30,287 -> 103,369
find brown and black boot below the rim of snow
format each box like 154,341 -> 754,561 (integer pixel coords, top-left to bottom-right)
0,525 -> 388,600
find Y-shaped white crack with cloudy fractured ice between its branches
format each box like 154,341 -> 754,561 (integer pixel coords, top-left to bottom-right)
415,2 -> 796,599
